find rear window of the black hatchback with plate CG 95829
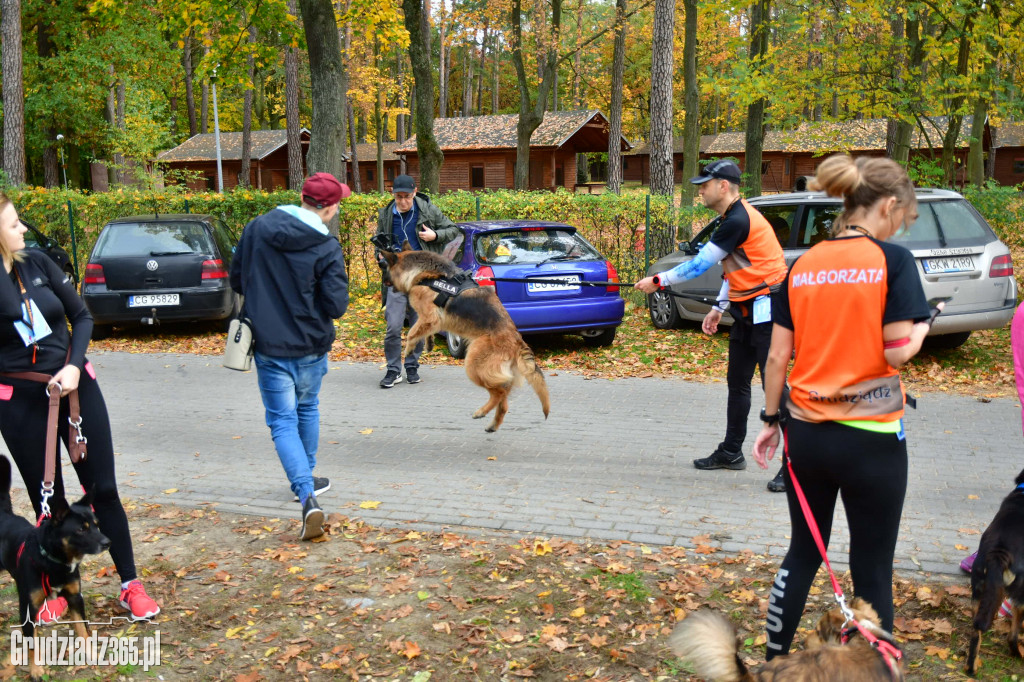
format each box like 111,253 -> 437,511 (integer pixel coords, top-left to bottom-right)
95,222 -> 214,258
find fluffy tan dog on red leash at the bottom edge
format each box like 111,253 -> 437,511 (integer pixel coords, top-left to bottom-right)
669,598 -> 903,682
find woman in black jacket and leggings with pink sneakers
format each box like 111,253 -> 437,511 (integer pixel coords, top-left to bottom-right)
0,195 -> 160,620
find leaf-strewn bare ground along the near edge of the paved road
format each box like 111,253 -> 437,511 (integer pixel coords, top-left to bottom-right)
8,504 -> 1020,682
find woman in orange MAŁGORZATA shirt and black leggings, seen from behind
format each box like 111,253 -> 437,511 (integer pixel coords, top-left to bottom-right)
754,155 -> 930,659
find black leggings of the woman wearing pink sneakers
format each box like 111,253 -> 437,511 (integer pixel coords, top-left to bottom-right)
0,372 -> 136,583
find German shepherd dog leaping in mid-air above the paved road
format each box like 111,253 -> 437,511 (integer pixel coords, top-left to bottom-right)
383,243 -> 551,433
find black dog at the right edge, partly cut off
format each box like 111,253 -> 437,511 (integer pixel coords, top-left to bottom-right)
967,464 -> 1024,675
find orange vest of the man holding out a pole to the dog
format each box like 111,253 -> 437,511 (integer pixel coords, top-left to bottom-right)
722,199 -> 785,301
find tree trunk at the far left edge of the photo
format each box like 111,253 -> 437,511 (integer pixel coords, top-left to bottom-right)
0,0 -> 26,186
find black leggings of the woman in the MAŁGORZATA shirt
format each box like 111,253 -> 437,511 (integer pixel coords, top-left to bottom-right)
767,419 -> 907,660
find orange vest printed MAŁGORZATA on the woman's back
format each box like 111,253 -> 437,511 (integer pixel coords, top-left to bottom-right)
787,238 -> 904,422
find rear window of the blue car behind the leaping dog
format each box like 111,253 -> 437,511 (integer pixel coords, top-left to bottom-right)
473,227 -> 601,265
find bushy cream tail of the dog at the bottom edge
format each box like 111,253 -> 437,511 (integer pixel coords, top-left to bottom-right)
669,610 -> 751,682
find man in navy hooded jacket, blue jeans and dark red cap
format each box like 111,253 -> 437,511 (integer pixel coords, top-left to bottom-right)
231,173 -> 352,540
